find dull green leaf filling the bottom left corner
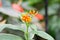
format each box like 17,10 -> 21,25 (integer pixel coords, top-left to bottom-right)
0,33 -> 23,40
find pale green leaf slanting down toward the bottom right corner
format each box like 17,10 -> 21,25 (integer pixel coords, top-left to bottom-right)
32,31 -> 54,40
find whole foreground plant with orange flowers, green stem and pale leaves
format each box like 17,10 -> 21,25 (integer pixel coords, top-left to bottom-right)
0,10 -> 54,40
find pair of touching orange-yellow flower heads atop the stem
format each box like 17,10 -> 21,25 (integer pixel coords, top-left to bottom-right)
22,10 -> 37,23
